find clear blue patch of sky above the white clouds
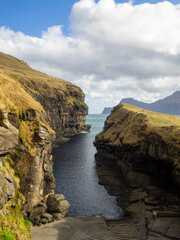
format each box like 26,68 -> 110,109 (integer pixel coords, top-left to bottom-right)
0,0 -> 179,36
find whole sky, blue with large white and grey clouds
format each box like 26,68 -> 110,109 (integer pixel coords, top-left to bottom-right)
0,0 -> 180,113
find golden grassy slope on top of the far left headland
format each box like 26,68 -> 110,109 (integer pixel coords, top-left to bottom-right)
0,52 -> 86,107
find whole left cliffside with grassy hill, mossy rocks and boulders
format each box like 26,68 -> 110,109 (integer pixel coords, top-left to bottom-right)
0,53 -> 89,240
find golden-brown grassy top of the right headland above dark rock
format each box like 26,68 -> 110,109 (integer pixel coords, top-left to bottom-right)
97,104 -> 180,148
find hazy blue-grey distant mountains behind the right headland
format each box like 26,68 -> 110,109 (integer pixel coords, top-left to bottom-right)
102,91 -> 180,115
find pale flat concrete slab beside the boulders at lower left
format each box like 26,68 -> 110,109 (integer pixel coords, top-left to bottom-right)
31,217 -> 107,240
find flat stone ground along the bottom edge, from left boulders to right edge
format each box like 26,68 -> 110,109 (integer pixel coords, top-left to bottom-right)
31,216 -> 180,240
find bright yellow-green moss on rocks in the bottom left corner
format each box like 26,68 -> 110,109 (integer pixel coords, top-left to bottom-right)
0,155 -> 31,240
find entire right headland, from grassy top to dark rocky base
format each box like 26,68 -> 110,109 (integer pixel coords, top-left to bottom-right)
94,104 -> 180,239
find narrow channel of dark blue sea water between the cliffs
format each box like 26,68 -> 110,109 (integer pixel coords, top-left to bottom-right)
53,114 -> 123,219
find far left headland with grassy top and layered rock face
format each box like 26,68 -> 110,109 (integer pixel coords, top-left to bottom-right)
0,52 -> 89,135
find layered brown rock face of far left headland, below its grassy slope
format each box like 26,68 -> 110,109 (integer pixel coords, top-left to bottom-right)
23,84 -> 90,136
